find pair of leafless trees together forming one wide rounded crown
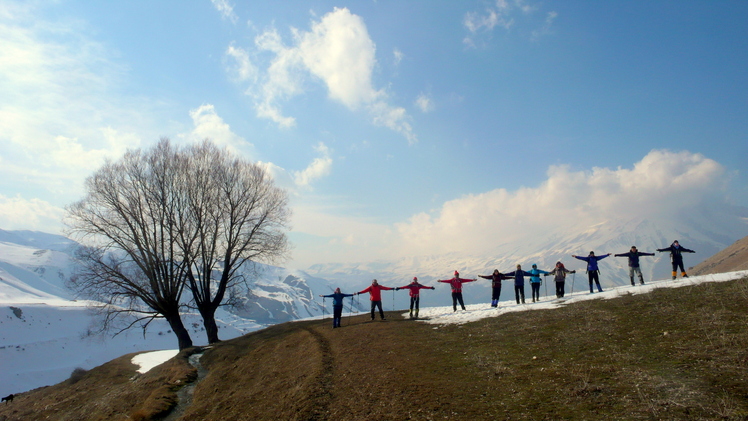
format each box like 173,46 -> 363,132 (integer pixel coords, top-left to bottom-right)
66,139 -> 290,349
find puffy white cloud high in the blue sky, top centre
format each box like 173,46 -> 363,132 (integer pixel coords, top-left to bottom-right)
227,8 -> 416,142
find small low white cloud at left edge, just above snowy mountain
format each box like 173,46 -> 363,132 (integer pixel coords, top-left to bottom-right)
0,194 -> 65,234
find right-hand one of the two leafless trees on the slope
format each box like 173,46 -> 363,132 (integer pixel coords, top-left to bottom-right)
179,141 -> 290,343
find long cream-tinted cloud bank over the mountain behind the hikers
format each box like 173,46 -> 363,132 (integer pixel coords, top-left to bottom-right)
396,150 -> 725,255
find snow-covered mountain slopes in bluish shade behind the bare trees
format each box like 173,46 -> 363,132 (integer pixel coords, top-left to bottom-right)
0,230 -> 350,396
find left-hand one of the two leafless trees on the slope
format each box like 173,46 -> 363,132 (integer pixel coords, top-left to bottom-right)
66,139 -> 192,349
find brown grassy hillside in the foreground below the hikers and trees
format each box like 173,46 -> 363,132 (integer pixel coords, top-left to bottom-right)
0,278 -> 748,420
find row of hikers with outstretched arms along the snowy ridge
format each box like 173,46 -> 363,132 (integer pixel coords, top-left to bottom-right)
320,240 -> 695,328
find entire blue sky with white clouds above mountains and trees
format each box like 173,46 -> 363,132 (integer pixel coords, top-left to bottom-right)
0,0 -> 748,268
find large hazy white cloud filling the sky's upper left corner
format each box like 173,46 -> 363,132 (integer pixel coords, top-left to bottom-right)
0,3 -> 152,196
